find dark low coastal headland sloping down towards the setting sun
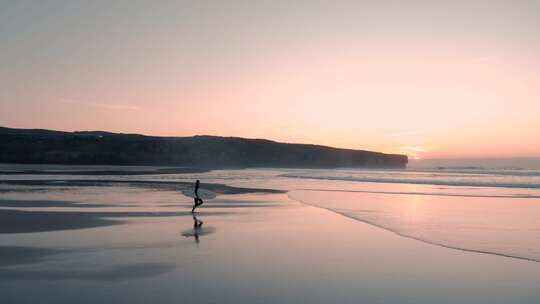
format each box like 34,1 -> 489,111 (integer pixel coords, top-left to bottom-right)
0,127 -> 408,169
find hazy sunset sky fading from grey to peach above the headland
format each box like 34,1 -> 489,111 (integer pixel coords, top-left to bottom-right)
0,0 -> 540,159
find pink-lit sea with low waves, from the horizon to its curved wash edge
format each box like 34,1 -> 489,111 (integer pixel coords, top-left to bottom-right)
130,169 -> 540,261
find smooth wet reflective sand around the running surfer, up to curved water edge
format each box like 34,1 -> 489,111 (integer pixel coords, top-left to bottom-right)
0,186 -> 540,303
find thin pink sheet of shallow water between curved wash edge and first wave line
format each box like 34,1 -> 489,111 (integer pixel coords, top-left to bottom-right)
289,191 -> 540,262
